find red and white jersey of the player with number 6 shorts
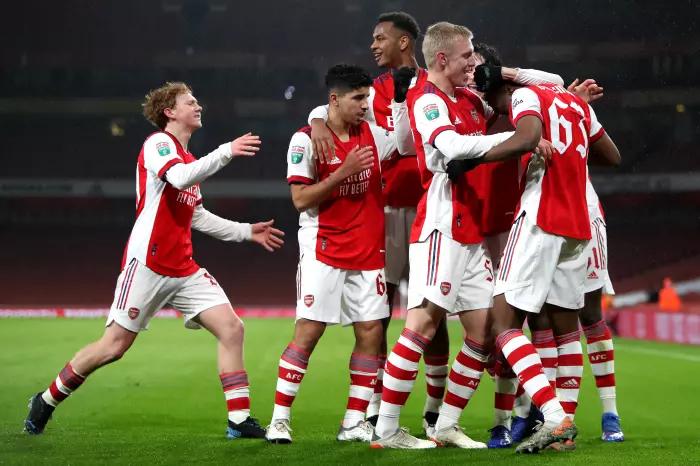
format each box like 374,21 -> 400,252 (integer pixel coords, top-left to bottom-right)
287,121 -> 396,270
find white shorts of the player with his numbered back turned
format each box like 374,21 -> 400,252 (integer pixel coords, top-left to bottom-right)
494,212 -> 588,313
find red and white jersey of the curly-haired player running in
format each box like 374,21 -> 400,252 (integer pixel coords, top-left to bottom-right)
122,132 -> 202,277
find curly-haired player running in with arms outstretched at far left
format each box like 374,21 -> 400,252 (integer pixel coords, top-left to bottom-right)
24,82 -> 283,439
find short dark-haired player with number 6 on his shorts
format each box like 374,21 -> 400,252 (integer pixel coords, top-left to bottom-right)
266,65 -> 412,443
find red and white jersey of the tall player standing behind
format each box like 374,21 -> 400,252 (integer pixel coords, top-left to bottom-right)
368,68 -> 428,208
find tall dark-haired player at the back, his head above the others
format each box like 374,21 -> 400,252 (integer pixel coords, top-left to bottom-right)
309,11 -> 449,431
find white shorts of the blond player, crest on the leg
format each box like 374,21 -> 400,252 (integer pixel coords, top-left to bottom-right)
408,230 -> 494,313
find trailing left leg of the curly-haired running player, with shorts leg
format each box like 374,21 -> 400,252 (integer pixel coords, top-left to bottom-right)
24,260 -> 161,434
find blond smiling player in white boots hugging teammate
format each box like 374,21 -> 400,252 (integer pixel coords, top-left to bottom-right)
371,22 -> 540,449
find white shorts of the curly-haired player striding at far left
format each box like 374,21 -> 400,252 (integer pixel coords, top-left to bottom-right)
106,259 -> 230,332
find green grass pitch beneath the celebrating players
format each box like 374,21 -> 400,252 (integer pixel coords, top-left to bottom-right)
0,319 -> 700,466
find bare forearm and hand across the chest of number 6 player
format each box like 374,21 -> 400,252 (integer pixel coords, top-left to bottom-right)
291,146 -> 374,212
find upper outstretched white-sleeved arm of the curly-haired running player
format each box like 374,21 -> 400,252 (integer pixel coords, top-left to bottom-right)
165,133 -> 261,189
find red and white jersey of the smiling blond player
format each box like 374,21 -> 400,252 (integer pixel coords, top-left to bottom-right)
408,81 -> 492,244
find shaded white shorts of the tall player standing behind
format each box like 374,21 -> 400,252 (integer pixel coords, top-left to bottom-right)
384,206 -> 416,285
